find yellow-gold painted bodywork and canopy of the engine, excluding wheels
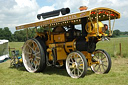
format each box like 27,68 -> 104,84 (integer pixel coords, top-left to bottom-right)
16,7 -> 120,67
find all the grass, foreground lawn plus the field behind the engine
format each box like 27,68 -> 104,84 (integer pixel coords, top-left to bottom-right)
0,37 -> 128,85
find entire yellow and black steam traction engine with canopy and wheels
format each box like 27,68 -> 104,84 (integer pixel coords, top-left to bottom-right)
16,8 -> 120,78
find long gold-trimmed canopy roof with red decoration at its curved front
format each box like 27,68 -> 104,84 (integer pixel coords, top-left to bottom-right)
16,7 -> 120,30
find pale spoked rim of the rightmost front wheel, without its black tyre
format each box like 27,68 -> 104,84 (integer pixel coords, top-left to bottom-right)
91,51 -> 109,74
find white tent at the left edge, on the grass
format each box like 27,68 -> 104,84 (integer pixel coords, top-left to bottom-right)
0,40 -> 9,62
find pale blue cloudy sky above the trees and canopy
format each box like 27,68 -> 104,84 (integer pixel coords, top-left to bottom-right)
0,0 -> 128,33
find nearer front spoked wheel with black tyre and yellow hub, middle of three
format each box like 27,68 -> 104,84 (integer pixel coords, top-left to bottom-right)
66,51 -> 87,78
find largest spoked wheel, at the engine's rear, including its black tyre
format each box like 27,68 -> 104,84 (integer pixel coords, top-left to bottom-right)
22,39 -> 46,72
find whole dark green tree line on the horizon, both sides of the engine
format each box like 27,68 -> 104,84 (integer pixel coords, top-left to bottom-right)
0,27 -> 128,42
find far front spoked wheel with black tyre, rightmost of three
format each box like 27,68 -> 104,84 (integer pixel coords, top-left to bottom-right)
91,49 -> 111,74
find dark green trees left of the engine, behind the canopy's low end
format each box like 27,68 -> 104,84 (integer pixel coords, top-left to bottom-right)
0,27 -> 36,42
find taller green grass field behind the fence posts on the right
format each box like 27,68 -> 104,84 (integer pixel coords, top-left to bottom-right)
97,37 -> 128,57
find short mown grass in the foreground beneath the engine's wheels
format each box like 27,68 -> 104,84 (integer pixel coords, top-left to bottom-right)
0,58 -> 128,85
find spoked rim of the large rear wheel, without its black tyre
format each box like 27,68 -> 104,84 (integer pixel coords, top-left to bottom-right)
22,39 -> 41,72
